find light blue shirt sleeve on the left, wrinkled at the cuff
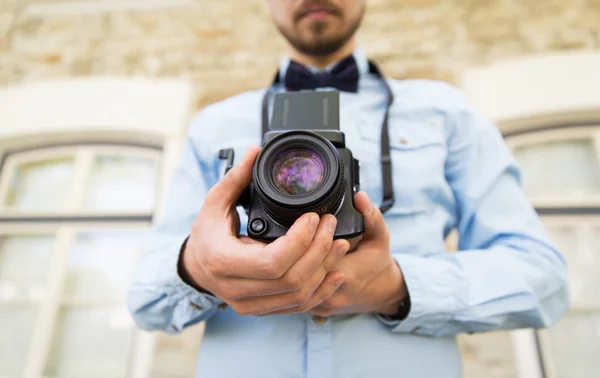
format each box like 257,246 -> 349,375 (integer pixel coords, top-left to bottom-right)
127,115 -> 224,333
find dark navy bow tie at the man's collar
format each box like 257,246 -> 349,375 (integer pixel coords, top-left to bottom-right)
285,55 -> 359,93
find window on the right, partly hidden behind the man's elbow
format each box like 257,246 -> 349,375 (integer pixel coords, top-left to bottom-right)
507,125 -> 600,378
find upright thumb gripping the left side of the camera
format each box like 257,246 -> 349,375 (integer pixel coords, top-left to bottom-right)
204,146 -> 260,212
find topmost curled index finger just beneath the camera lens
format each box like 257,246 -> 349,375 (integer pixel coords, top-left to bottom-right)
216,213 -> 319,280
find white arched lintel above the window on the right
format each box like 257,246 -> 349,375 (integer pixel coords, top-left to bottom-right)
461,51 -> 600,132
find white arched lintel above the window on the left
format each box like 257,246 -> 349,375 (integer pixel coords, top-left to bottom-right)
0,78 -> 194,141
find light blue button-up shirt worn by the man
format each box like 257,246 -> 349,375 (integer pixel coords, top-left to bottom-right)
128,50 -> 568,378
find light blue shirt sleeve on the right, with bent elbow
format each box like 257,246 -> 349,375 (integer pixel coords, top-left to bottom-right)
379,91 -> 569,336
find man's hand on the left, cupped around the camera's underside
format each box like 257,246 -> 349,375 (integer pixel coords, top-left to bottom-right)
182,146 -> 350,315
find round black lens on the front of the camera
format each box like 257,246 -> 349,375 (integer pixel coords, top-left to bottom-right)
254,131 -> 346,226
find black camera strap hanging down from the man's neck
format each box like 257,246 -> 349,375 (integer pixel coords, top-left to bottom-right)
262,60 -> 394,214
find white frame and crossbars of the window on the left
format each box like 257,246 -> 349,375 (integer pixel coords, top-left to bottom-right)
0,140 -> 164,378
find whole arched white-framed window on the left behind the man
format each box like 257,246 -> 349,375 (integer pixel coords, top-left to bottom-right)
0,144 -> 160,378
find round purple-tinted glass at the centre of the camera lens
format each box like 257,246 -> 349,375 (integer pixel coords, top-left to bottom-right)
272,149 -> 325,195
